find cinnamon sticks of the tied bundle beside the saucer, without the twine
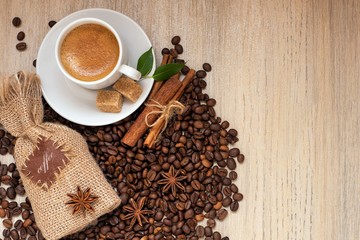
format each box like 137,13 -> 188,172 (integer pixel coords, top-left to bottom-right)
121,54 -> 195,148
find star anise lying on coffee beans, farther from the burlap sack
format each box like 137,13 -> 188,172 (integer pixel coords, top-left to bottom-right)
157,166 -> 187,197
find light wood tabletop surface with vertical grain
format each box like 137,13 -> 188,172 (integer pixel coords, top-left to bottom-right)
0,0 -> 360,240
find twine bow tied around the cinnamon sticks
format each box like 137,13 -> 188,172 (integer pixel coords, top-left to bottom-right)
145,99 -> 185,134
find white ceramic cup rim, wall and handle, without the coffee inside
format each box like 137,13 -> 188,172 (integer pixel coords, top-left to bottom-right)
55,18 -> 141,89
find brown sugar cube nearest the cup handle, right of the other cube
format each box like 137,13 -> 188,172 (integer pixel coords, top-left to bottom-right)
113,75 -> 142,102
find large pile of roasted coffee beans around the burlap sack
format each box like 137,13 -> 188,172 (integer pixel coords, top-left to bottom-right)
0,36 -> 244,240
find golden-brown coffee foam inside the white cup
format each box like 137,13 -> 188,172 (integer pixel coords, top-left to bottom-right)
60,24 -> 120,81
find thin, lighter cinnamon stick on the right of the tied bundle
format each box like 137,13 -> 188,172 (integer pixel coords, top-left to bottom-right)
144,69 -> 195,148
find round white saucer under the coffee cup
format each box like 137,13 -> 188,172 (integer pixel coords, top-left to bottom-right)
36,8 -> 156,126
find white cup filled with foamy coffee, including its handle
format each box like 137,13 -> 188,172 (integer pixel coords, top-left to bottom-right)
55,18 -> 141,89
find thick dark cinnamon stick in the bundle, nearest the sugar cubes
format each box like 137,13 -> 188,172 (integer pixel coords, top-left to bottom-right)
121,74 -> 182,147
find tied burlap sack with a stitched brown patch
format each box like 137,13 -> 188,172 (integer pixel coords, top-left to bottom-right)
0,72 -> 120,240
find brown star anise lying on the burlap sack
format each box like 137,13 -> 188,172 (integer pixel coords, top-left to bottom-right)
65,186 -> 99,215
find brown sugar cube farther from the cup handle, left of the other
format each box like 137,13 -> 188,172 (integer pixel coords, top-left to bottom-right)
96,90 -> 123,113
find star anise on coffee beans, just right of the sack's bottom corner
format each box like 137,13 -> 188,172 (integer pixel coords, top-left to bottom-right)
123,197 -> 153,229
